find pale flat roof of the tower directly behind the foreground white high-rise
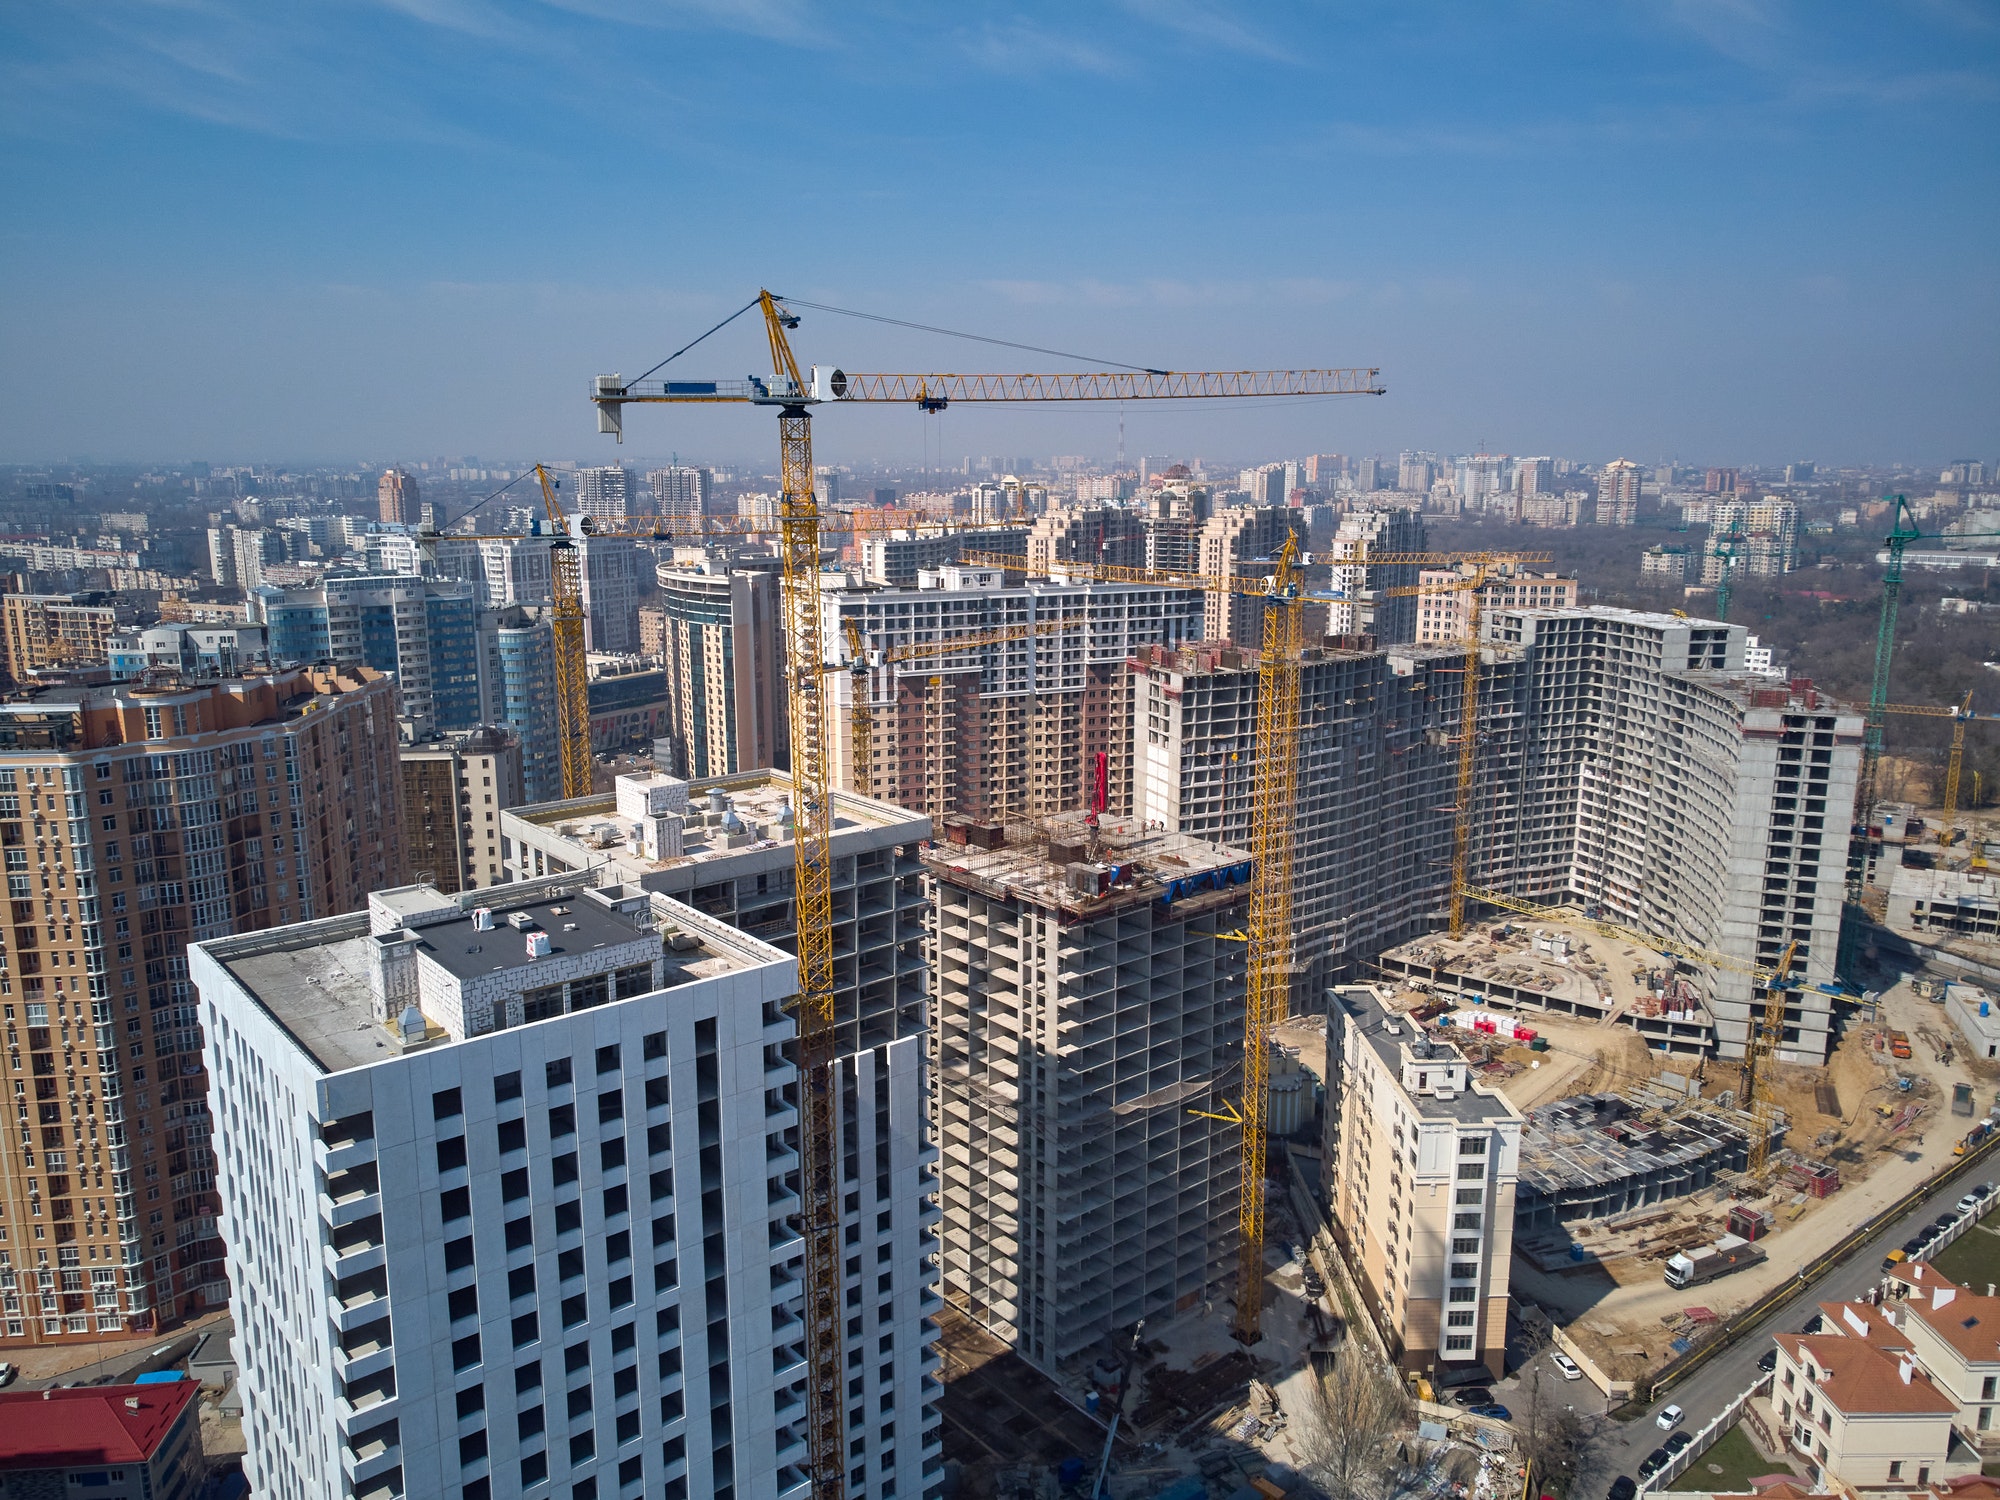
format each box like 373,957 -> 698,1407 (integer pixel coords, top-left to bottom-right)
500,770 -> 930,874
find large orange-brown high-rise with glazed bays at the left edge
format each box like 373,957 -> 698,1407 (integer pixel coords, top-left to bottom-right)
0,668 -> 408,1358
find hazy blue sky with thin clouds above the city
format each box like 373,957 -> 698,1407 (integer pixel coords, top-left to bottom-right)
0,0 -> 2000,464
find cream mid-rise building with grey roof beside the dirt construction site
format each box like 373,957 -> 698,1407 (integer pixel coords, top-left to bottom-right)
1326,984 -> 1522,1378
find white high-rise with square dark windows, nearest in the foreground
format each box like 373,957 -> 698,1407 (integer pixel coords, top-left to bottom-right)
201,882 -> 936,1500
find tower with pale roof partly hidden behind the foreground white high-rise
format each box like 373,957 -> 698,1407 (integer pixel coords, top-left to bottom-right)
500,770 -> 940,1500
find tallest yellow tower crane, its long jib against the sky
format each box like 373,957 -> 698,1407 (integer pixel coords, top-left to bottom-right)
590,290 -> 1384,1500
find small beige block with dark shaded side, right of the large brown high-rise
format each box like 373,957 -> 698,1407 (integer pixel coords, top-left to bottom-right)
400,726 -> 522,892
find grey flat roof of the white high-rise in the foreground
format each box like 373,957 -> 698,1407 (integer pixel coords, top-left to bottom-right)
219,876 -> 790,1072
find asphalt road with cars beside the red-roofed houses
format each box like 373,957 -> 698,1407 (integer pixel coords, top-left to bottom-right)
1494,1170 -> 2000,1500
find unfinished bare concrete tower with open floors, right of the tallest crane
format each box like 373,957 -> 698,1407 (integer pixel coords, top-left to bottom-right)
924,814 -> 1250,1370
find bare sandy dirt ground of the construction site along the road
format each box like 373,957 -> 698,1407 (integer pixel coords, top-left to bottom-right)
1512,984 -> 1992,1378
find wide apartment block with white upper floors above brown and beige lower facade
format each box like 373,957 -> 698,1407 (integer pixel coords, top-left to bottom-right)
824,568 -> 1202,836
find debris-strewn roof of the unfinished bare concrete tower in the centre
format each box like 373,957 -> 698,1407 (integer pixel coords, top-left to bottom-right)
924,812 -> 1250,916
